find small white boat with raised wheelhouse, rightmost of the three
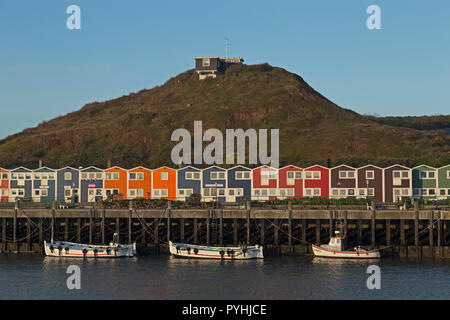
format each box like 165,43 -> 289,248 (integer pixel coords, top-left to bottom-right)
311,231 -> 381,259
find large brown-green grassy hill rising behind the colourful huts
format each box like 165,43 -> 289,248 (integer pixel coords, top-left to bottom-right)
0,64 -> 450,167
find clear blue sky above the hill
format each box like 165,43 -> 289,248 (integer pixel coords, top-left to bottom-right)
0,0 -> 450,138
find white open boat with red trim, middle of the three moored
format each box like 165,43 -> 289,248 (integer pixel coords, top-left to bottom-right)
169,241 -> 264,260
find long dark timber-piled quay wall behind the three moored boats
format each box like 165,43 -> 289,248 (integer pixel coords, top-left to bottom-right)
0,206 -> 450,259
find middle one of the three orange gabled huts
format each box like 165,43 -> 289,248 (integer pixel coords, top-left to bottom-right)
128,167 -> 152,199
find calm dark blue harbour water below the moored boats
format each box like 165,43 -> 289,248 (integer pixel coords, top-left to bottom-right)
0,254 -> 450,300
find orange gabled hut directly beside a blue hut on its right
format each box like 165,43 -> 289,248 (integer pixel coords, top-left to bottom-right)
152,167 -> 177,200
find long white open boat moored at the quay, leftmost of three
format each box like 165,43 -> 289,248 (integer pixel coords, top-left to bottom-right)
44,233 -> 136,259
